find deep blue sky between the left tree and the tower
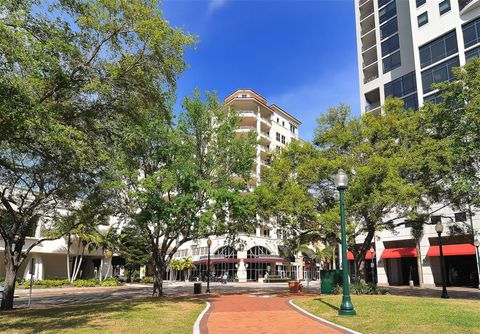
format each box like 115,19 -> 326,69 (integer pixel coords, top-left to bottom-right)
162,0 -> 359,140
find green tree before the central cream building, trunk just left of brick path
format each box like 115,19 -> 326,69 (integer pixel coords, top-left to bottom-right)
119,91 -> 255,296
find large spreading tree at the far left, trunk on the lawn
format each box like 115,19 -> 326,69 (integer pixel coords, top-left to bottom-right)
0,0 -> 194,309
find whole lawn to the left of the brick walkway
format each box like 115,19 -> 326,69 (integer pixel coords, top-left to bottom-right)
0,299 -> 205,334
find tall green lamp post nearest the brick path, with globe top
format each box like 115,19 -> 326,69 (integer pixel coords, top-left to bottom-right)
334,169 -> 357,315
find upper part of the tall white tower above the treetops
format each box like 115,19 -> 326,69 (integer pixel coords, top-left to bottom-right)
355,0 -> 480,113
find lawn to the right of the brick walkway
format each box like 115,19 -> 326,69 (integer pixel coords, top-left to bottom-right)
294,295 -> 480,334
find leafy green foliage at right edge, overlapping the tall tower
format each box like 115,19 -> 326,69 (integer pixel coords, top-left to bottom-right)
422,58 -> 480,214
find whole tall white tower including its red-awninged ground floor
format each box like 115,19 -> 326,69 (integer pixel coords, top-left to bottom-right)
350,0 -> 480,287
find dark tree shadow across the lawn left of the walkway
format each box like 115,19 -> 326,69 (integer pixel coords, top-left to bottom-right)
0,297 -> 204,333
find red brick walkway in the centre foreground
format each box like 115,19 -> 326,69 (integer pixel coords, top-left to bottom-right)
200,293 -> 345,334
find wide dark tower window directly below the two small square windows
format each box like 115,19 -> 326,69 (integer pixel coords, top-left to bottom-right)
420,30 -> 458,68
